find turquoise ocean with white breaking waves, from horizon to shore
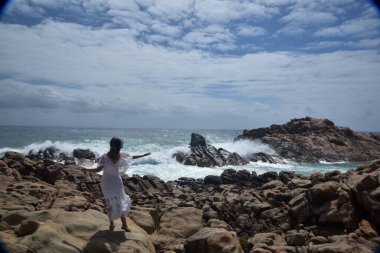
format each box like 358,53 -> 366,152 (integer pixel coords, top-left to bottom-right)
0,126 -> 358,181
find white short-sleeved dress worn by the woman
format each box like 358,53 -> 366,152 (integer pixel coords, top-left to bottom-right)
98,153 -> 133,221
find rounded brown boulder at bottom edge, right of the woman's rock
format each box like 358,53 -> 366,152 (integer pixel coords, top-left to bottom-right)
185,227 -> 243,253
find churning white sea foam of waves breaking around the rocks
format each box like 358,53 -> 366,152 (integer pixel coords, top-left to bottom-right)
0,135 -> 354,181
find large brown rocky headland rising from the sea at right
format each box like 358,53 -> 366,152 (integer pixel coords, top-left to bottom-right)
236,117 -> 380,163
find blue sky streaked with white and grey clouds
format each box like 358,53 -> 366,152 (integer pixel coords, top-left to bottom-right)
0,0 -> 380,131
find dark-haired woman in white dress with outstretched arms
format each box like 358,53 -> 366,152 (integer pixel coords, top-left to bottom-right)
81,137 -> 151,232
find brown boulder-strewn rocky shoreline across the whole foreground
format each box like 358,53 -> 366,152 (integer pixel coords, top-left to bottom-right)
0,152 -> 380,253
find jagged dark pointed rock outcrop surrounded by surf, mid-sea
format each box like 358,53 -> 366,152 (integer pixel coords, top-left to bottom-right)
173,133 -> 249,167
